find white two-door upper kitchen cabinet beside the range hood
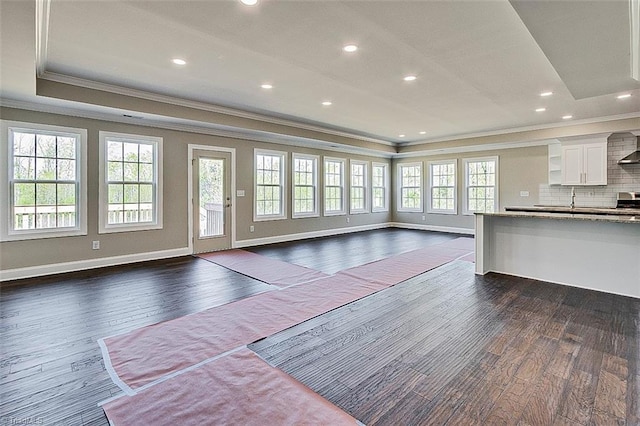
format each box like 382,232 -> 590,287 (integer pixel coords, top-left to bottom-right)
561,136 -> 607,186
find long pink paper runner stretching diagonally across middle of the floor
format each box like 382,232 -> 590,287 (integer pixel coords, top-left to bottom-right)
100,238 -> 469,393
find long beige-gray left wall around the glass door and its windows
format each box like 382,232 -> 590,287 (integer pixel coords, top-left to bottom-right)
0,108 -> 391,270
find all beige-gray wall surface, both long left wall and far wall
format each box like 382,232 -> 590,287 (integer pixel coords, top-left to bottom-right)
0,108 -> 624,270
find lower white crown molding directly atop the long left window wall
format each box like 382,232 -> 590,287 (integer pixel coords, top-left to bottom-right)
0,99 -> 395,158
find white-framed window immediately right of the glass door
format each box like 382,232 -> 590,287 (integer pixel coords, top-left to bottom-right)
254,149 -> 287,221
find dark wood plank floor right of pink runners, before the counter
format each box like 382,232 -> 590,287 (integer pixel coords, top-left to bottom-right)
250,261 -> 640,425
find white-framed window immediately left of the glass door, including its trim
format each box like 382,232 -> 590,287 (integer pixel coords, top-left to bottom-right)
99,132 -> 162,234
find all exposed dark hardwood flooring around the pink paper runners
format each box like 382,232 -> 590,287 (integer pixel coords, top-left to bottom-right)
0,229 -> 640,425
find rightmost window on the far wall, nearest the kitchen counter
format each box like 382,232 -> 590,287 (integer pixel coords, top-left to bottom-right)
464,157 -> 498,214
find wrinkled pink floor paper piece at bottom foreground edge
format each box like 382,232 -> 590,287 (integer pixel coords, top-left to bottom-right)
102,349 -> 356,426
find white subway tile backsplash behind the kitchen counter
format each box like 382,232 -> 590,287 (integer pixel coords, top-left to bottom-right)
539,133 -> 640,207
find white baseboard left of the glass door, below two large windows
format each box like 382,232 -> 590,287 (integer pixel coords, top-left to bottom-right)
0,247 -> 191,281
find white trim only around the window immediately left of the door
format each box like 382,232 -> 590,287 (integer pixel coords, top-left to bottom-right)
98,131 -> 163,234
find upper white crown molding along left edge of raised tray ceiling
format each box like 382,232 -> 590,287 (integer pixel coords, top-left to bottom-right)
40,70 -> 396,146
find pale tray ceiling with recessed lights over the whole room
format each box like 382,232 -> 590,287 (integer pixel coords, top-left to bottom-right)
0,0 -> 640,148
